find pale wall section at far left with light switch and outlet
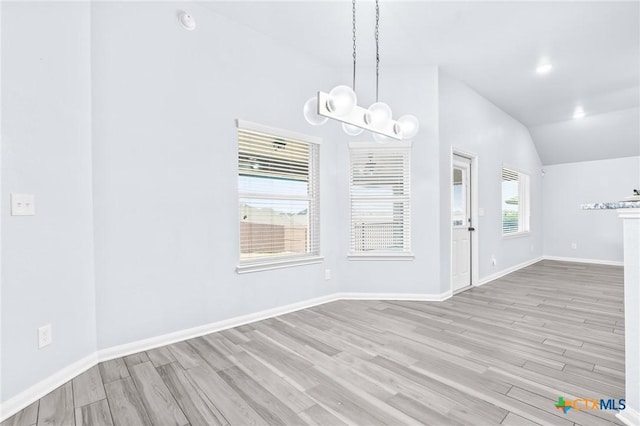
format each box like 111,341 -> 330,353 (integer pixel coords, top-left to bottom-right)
0,2 -> 96,400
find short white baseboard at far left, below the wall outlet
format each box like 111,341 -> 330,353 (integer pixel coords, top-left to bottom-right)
0,352 -> 98,422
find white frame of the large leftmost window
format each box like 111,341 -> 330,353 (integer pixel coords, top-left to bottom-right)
236,119 -> 324,274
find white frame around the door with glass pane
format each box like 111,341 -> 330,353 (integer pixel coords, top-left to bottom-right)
447,147 -> 481,293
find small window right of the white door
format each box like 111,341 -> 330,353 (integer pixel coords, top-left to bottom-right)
502,168 -> 529,235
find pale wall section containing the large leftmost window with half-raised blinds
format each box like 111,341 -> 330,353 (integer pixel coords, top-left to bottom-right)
91,2 -> 348,349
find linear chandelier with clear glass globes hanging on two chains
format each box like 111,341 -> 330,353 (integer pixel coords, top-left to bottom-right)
303,0 -> 420,142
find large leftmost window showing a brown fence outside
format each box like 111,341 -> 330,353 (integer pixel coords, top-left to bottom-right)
237,120 -> 321,272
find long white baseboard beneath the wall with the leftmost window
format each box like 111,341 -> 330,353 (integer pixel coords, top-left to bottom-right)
97,293 -> 338,362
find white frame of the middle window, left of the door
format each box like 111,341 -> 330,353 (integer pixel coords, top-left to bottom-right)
347,141 -> 415,260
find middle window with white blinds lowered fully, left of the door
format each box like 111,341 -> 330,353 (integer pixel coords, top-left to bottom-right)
349,142 -> 412,258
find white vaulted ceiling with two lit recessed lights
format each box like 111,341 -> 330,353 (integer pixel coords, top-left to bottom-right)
207,0 -> 640,164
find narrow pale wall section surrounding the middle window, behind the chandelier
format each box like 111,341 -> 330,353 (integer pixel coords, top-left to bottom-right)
332,64 -> 442,295
